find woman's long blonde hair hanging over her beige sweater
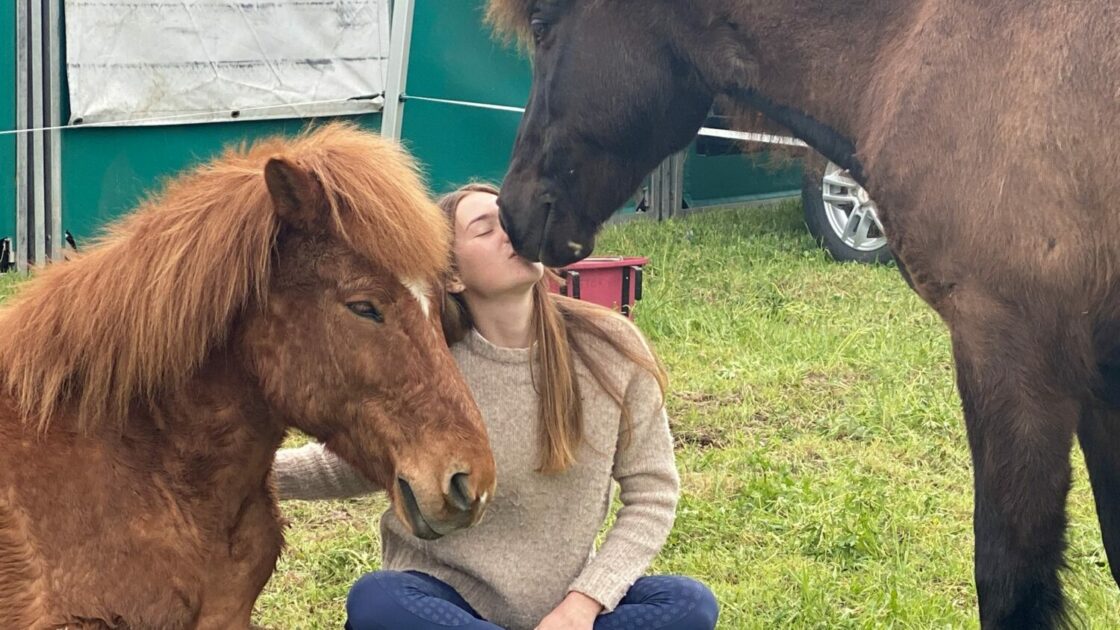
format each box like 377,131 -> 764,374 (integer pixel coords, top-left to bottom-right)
438,183 -> 668,474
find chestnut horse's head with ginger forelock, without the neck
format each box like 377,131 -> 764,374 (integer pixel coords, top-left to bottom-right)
247,126 -> 495,538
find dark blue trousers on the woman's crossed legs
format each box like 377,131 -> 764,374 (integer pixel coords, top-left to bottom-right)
346,571 -> 719,630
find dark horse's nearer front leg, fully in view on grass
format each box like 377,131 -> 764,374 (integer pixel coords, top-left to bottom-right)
950,311 -> 1081,629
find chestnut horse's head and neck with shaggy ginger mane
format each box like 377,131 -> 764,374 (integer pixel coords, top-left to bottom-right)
0,123 -> 495,538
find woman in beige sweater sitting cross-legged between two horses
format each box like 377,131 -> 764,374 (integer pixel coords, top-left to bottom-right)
274,184 -> 718,630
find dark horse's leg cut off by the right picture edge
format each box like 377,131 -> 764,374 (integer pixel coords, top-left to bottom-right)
1077,394 -> 1120,585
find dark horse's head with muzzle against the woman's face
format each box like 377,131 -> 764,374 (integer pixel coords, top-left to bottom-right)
491,0 -> 712,266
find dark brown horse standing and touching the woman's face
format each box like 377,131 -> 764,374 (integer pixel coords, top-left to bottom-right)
489,0 -> 1120,628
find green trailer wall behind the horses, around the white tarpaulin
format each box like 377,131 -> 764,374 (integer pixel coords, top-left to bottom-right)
0,0 -> 801,268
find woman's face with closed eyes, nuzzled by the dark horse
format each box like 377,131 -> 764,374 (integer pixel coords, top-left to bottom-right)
454,193 -> 544,298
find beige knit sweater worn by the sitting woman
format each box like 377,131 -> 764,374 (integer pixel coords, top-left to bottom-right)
274,317 -> 680,630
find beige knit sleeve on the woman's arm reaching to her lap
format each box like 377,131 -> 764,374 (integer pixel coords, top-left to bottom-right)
569,360 -> 680,612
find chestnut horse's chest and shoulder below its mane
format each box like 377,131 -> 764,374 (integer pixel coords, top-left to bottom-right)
0,359 -> 284,629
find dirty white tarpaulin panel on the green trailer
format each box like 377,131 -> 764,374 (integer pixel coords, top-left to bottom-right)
65,0 -> 390,124
